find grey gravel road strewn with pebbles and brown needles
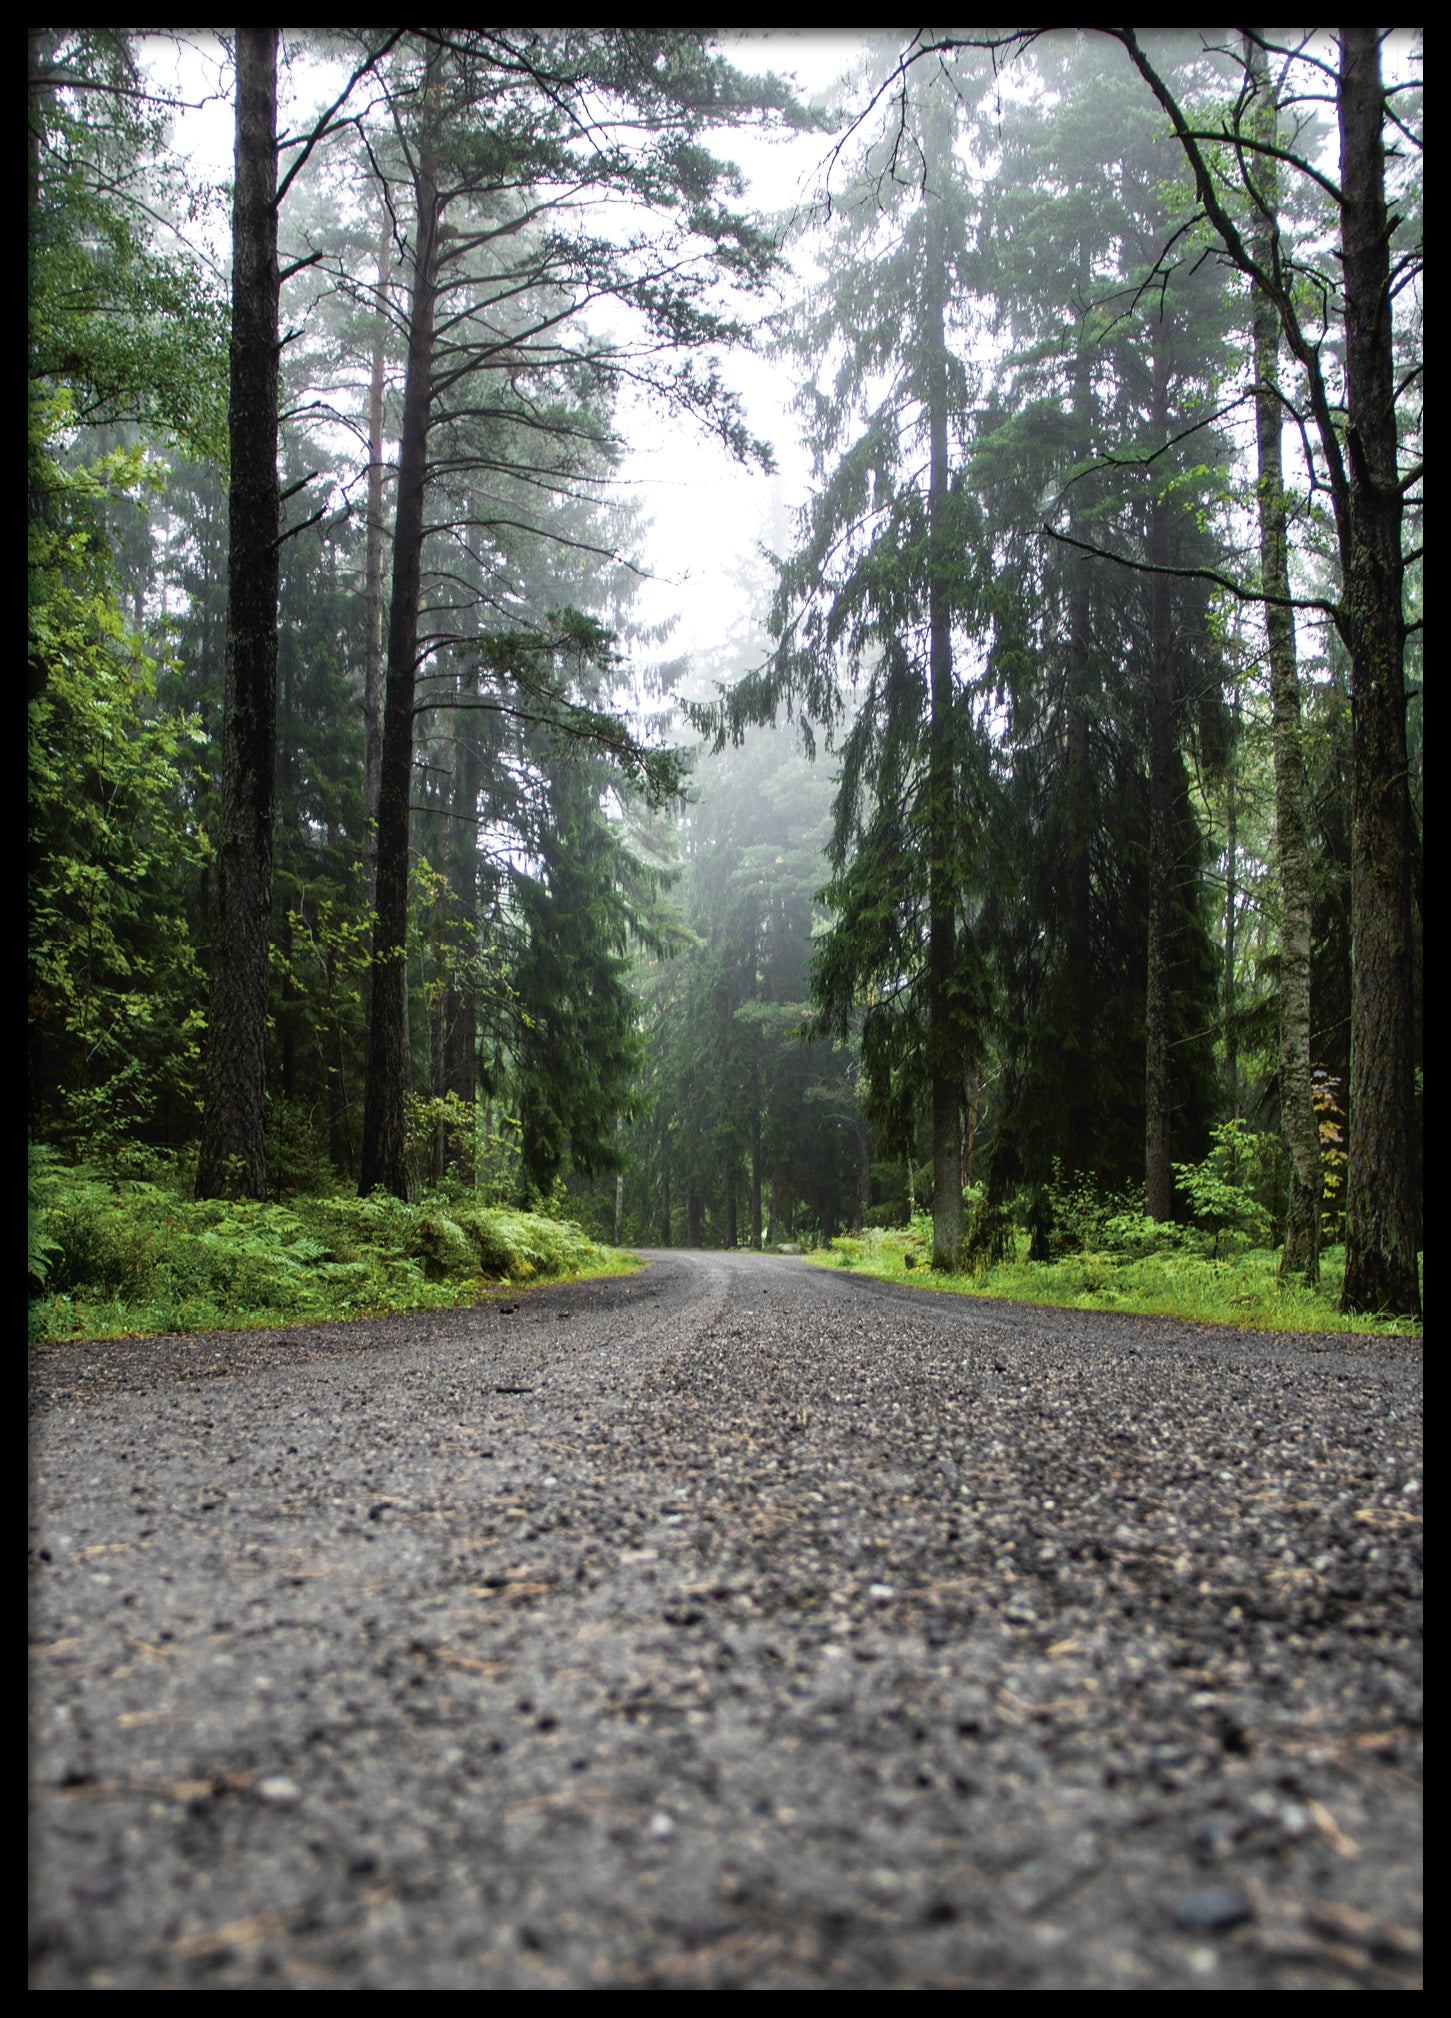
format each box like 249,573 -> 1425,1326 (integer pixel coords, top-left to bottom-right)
30,1253 -> 1421,1990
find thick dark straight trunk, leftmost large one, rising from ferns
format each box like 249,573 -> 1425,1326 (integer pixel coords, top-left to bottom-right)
196,28 -> 281,1199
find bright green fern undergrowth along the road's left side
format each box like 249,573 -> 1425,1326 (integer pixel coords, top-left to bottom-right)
28,1154 -> 640,1344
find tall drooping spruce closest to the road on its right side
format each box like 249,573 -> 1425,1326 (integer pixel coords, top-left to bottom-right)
731,47 -> 991,1269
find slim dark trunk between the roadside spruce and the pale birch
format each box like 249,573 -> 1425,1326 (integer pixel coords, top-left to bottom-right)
1144,345 -> 1175,1219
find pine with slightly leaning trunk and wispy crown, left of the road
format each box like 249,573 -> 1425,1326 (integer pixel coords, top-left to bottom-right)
361,30 -> 799,1197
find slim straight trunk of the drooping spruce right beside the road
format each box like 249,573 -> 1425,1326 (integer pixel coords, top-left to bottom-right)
922,153 -> 965,1273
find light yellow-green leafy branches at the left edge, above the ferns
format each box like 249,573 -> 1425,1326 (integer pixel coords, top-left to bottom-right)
28,425 -> 210,1146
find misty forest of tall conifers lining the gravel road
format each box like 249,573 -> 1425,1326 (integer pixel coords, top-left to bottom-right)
26,28 -> 1425,1334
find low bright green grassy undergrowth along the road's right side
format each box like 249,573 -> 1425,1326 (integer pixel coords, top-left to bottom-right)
823,1215 -> 1421,1336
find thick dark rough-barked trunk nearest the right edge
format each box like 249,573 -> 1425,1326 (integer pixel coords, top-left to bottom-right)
1340,28 -> 1421,1316
